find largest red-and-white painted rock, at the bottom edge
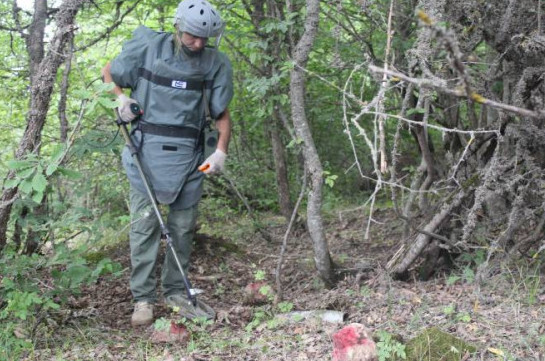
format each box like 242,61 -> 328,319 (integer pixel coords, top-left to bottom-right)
333,323 -> 377,361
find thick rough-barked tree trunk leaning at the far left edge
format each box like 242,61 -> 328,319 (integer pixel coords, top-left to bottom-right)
0,0 -> 88,251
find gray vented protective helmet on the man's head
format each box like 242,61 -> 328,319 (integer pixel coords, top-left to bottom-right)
174,0 -> 225,38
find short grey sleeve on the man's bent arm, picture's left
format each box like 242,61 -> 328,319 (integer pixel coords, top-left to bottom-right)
110,26 -> 154,89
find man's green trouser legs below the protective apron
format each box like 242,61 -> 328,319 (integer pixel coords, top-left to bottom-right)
129,189 -> 197,303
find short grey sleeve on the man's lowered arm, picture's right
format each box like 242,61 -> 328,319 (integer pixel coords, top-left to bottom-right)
210,53 -> 233,119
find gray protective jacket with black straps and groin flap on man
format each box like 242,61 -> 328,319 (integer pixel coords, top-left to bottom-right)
111,26 -> 233,209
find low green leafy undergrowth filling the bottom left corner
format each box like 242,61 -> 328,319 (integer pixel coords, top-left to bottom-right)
0,245 -> 121,360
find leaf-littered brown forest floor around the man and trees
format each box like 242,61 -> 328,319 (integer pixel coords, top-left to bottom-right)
27,207 -> 545,361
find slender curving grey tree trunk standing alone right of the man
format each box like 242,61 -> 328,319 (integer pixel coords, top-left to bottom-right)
290,0 -> 334,285
